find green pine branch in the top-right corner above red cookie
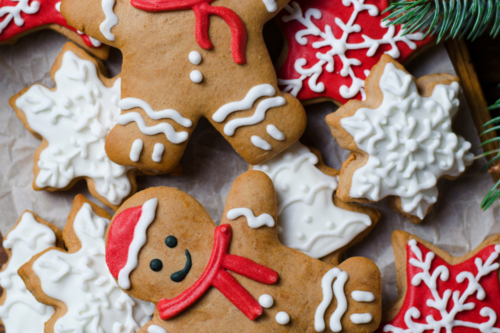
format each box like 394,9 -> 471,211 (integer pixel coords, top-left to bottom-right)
384,0 -> 500,43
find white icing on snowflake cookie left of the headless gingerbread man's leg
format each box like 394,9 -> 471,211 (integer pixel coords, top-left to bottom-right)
16,51 -> 131,205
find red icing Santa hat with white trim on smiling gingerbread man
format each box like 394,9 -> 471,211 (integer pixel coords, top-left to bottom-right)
106,198 -> 158,289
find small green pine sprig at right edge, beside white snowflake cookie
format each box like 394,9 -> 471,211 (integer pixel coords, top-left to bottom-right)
476,87 -> 500,210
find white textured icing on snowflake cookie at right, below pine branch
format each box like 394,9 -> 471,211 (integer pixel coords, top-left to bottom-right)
341,63 -> 474,219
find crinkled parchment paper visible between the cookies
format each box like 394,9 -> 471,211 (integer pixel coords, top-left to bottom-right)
0,32 -> 500,303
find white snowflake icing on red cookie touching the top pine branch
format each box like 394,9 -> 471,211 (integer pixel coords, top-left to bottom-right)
278,0 -> 423,100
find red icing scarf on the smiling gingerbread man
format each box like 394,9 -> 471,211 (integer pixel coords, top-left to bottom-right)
158,224 -> 279,320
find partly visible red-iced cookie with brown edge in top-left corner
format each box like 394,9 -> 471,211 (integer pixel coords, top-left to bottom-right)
0,0 -> 109,59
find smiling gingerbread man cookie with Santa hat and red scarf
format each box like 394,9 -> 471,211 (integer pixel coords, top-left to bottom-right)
106,171 -> 381,333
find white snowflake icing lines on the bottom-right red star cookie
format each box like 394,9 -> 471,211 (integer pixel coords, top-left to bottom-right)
384,239 -> 500,333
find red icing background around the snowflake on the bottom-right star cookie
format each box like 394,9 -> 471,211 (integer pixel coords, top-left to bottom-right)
376,242 -> 500,333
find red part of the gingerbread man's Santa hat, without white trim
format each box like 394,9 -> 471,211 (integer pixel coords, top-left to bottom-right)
106,206 -> 142,279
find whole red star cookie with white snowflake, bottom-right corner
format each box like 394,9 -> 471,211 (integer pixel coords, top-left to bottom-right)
378,231 -> 500,333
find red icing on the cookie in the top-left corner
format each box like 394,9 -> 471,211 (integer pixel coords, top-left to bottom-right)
0,0 -> 95,48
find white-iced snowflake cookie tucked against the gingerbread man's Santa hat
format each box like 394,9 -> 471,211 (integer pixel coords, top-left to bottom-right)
19,195 -> 154,333
